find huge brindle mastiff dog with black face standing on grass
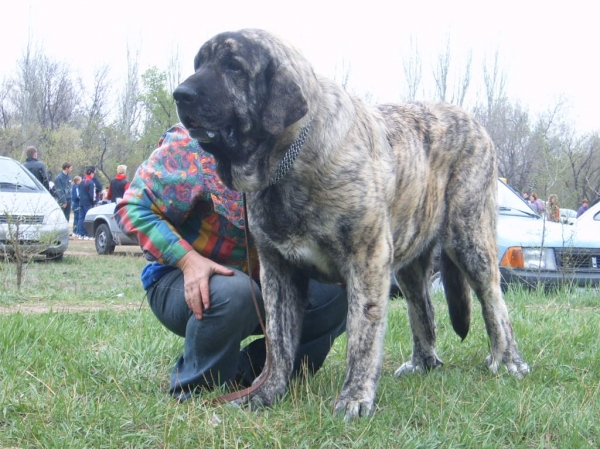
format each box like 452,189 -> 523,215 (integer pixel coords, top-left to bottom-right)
174,29 -> 529,419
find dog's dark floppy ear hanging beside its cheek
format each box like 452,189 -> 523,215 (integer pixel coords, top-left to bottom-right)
262,65 -> 308,136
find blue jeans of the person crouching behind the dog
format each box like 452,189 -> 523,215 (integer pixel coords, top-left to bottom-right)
147,269 -> 348,401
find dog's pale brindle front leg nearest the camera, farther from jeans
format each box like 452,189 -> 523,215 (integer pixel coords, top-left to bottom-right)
334,264 -> 391,421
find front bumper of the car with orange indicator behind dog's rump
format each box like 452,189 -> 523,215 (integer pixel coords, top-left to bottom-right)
500,267 -> 600,290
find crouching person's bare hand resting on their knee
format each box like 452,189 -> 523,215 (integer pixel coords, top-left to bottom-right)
177,251 -> 233,320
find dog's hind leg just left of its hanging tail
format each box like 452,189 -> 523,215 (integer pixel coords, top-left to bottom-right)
395,243 -> 442,376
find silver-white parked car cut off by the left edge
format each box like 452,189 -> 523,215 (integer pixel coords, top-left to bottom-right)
0,156 -> 69,260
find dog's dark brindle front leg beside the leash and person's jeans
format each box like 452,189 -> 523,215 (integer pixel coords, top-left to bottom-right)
249,252 -> 308,408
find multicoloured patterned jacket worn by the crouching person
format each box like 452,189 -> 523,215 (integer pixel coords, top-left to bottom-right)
115,125 -> 258,288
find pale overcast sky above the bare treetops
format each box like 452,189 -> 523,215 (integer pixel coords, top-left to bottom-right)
0,0 -> 600,132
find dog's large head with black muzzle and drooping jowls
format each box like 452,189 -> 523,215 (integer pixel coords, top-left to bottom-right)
173,29 -> 314,191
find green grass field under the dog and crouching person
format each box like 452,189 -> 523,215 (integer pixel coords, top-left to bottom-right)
0,241 -> 600,448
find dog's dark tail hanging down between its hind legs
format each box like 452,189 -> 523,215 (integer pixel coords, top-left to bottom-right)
440,249 -> 471,340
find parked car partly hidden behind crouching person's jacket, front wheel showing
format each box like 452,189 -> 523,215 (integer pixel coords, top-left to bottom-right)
83,203 -> 138,255
